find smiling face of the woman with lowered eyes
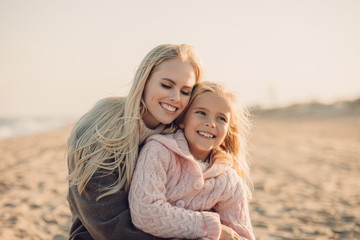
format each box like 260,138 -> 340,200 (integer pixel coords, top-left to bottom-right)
143,58 -> 196,128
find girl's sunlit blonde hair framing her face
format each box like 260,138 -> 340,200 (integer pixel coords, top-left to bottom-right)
176,81 -> 252,199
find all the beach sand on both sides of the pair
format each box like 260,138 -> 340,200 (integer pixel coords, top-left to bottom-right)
0,117 -> 360,240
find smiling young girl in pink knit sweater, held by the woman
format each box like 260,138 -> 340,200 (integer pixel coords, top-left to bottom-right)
129,82 -> 255,239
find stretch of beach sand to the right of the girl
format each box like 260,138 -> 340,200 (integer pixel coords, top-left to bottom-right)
250,118 -> 360,240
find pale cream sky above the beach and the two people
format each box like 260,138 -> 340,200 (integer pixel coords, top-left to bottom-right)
0,0 -> 360,118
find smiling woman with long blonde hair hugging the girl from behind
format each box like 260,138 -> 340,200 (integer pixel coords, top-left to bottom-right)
68,44 -> 202,240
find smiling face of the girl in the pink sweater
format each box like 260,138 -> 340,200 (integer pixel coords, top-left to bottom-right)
180,92 -> 231,161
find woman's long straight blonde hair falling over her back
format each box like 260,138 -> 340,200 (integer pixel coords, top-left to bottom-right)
68,44 -> 203,199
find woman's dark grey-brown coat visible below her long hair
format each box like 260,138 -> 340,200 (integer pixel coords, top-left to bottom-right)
68,162 -> 167,240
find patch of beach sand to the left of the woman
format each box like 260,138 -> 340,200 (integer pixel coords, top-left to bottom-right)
0,126 -> 70,240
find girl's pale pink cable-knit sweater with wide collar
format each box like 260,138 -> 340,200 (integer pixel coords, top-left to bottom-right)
129,131 -> 255,239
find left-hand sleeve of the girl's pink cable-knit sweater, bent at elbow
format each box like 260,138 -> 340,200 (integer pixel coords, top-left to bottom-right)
129,141 -> 221,239
